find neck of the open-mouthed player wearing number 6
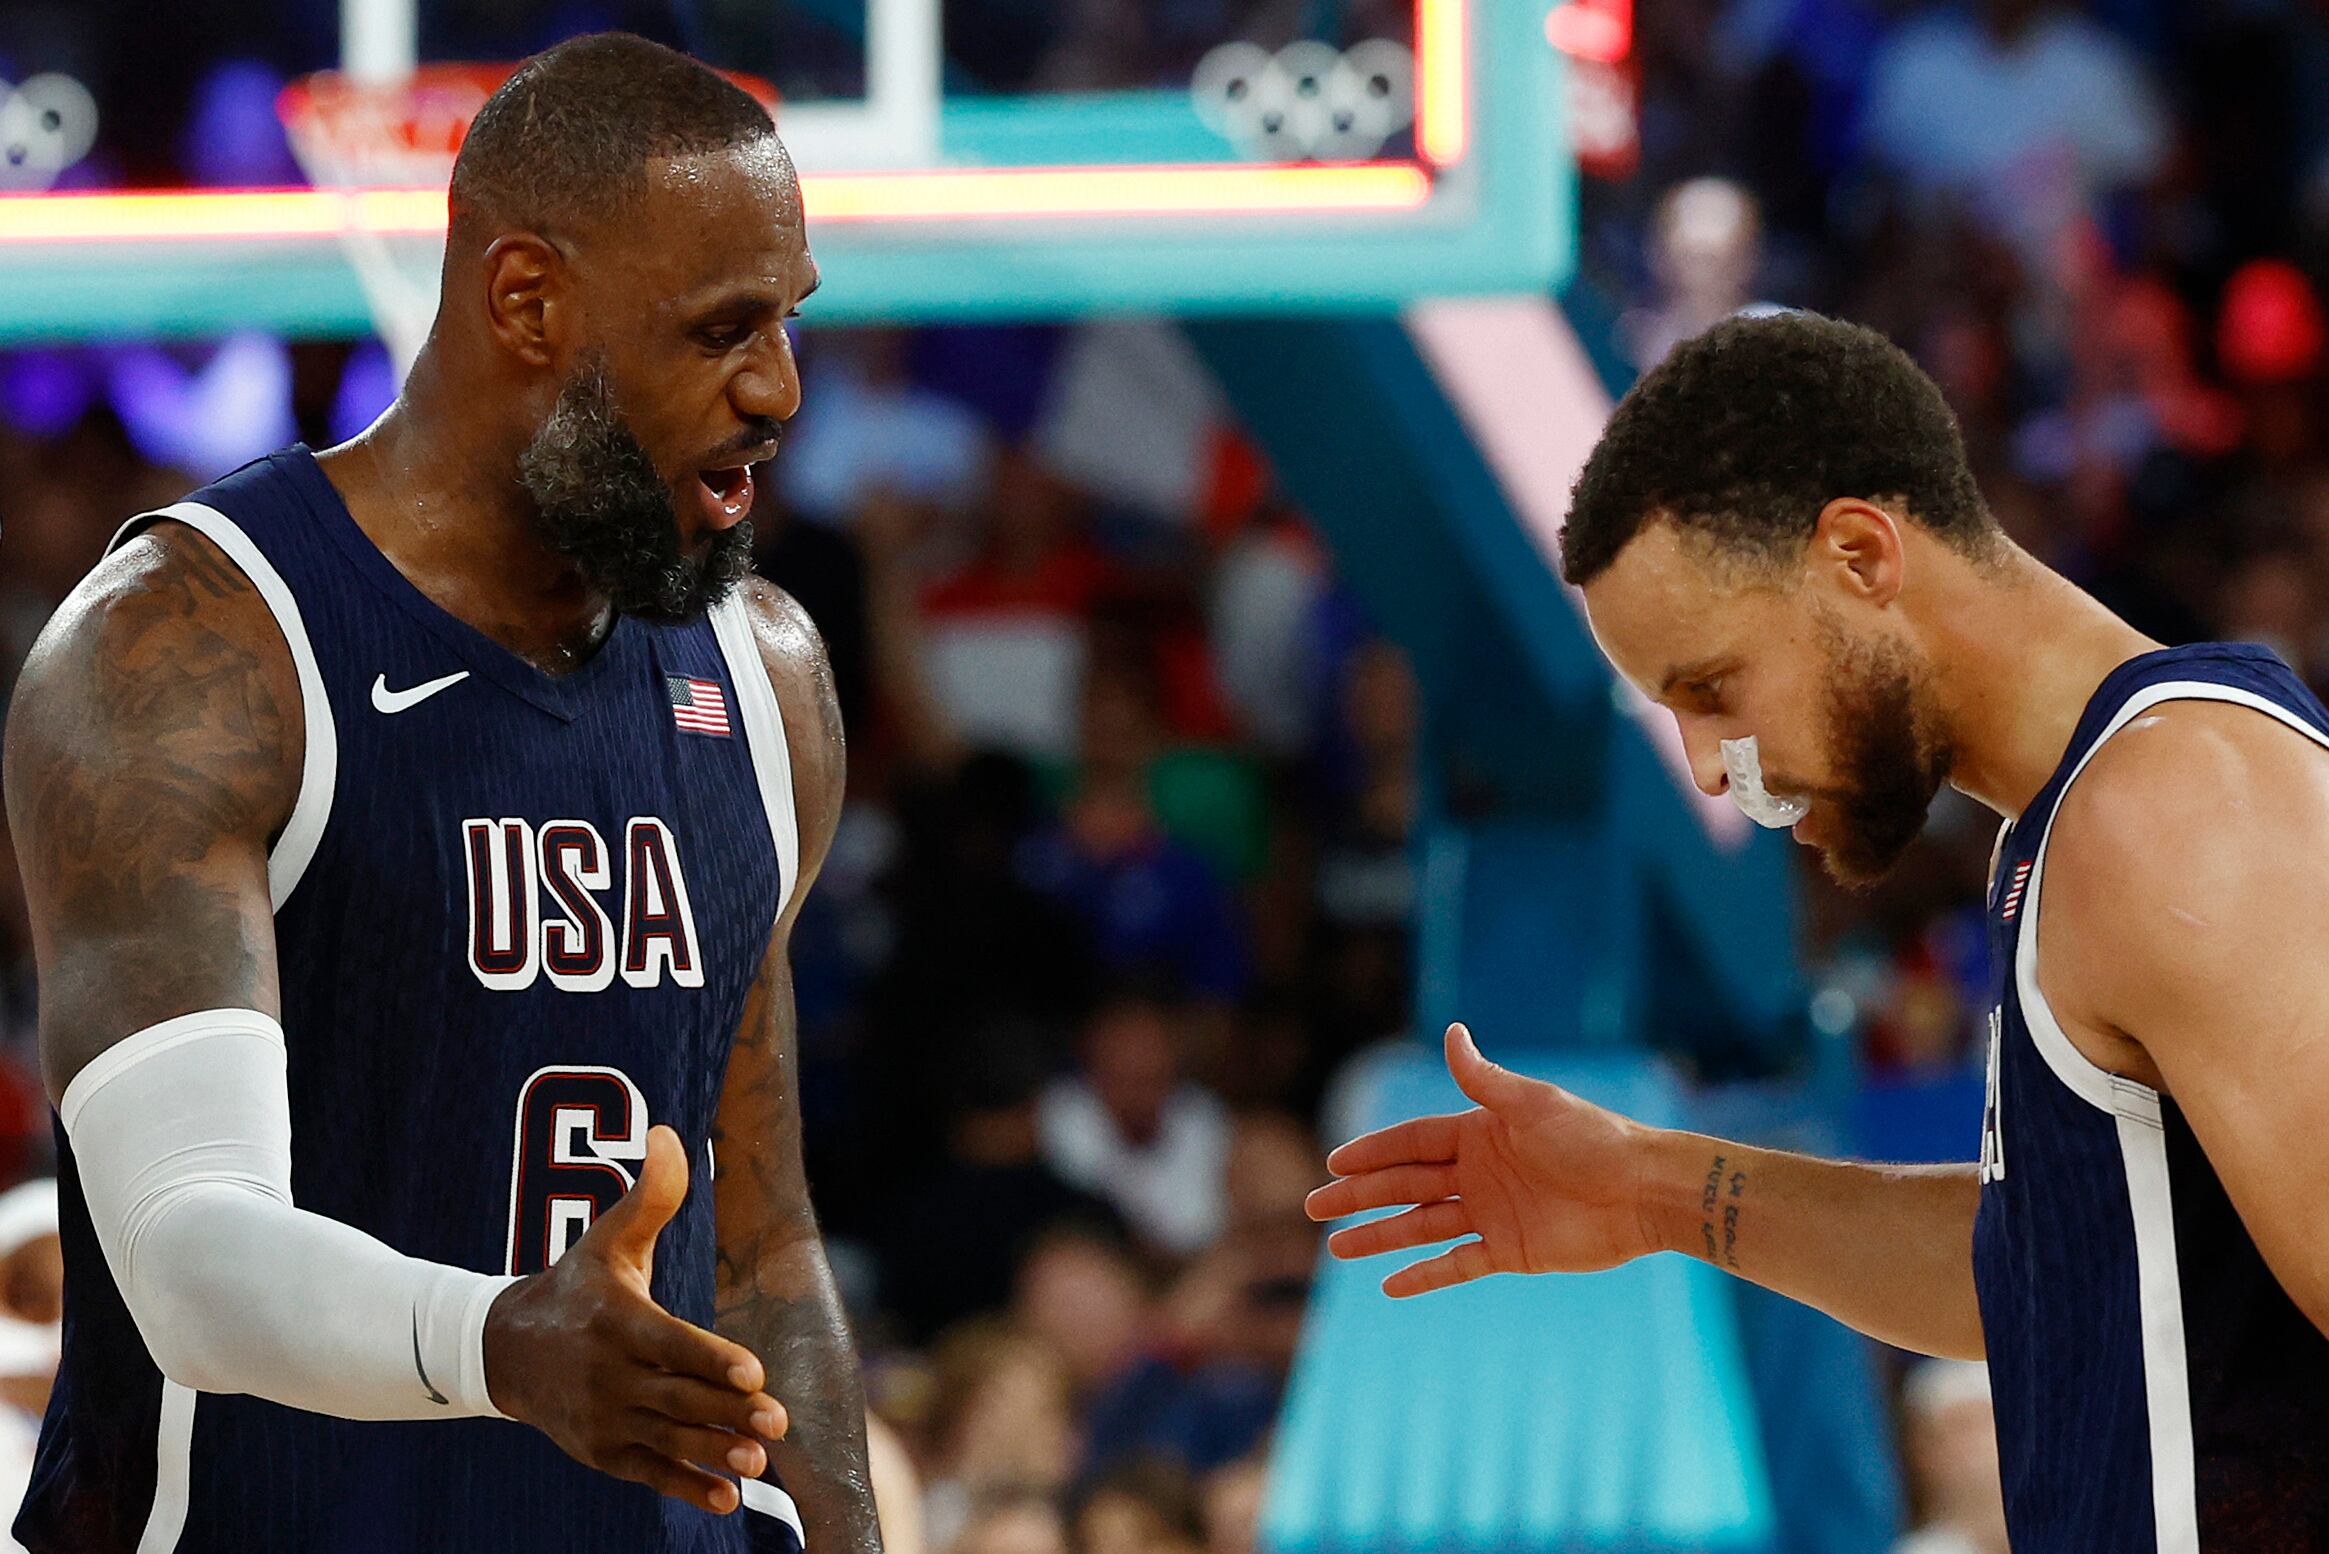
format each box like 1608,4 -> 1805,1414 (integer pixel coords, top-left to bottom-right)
321,368 -> 613,673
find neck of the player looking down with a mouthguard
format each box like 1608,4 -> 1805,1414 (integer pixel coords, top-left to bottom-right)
1928,548 -> 2159,818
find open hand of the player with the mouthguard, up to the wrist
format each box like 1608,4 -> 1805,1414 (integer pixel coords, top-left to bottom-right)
1309,1025 -> 1656,1295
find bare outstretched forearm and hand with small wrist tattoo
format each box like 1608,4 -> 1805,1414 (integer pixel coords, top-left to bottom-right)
1309,1025 -> 1982,1358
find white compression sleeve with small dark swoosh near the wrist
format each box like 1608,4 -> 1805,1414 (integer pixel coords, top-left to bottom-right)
58,1009 -> 515,1419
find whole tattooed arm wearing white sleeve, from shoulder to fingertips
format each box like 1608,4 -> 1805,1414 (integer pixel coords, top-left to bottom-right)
5,524 -> 783,1510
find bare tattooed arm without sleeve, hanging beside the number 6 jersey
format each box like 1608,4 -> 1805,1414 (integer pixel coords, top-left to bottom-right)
713,582 -> 880,1554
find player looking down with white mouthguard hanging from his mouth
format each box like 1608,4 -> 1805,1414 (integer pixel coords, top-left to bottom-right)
1311,315 -> 2329,1554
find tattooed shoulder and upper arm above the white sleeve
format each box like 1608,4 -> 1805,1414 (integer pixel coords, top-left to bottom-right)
5,522 -> 305,1095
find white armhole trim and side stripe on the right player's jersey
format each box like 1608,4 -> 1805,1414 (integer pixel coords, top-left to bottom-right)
2015,680 -> 2329,1554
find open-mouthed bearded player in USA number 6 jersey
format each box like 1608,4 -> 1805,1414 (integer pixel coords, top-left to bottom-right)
7,35 -> 880,1554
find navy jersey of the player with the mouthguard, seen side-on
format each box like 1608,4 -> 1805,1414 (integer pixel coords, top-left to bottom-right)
1973,643 -> 2329,1554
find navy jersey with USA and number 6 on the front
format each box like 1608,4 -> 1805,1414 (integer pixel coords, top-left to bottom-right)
16,447 -> 799,1554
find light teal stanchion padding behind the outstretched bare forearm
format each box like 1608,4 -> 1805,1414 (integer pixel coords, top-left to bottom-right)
1262,1048 -> 1775,1554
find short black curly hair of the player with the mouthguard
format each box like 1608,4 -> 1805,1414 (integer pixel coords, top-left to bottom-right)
1560,312 -> 2003,585
